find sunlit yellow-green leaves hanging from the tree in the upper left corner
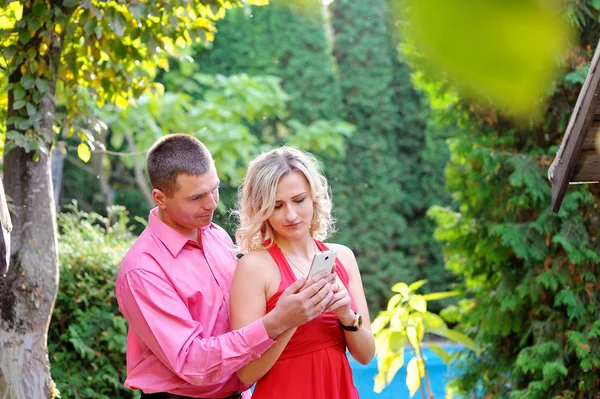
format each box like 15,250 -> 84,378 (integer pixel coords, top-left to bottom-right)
0,0 -> 268,155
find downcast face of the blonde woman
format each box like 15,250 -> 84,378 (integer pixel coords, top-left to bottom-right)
268,170 -> 314,239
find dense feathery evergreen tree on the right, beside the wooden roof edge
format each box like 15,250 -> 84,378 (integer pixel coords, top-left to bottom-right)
404,1 -> 600,399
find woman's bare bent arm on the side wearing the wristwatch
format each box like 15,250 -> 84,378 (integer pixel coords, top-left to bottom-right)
327,244 -> 375,364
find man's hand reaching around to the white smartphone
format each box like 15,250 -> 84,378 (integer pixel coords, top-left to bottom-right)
263,270 -> 335,339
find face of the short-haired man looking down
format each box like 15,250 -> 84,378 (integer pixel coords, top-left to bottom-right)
157,166 -> 220,235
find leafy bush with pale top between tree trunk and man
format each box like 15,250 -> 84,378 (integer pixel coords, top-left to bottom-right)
48,204 -> 139,399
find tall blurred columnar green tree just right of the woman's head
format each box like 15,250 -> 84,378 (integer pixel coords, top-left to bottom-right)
328,0 -> 449,308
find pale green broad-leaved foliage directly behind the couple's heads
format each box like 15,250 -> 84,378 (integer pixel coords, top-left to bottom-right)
104,70 -> 354,186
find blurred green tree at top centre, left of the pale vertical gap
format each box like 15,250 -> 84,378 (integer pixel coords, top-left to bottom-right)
195,0 -> 341,123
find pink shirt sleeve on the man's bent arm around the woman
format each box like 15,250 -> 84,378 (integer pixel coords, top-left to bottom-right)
116,258 -> 275,385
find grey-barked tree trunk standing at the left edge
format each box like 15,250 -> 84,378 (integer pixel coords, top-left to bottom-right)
0,11 -> 62,399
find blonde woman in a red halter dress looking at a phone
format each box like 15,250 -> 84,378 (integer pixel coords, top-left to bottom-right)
231,147 -> 375,399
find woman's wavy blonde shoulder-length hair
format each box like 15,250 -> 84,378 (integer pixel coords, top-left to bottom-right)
235,146 -> 333,253
